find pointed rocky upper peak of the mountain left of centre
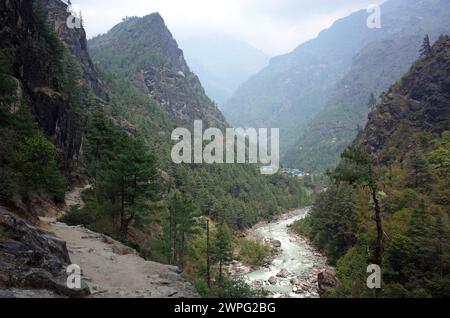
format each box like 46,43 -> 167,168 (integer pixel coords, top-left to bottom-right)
89,13 -> 226,127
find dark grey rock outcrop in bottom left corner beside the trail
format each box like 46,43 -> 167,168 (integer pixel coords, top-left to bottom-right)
0,207 -> 90,297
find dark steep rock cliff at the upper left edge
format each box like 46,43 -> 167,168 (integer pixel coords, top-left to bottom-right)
0,0 -> 83,162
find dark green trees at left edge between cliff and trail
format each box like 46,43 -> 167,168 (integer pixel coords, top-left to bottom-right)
0,104 -> 67,202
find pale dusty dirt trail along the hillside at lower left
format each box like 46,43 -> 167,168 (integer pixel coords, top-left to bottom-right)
41,187 -> 197,298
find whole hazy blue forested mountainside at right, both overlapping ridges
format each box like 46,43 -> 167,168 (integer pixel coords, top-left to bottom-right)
223,0 -> 449,161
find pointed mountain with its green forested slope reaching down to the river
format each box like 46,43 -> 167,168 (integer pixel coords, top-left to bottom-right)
88,13 -> 305,229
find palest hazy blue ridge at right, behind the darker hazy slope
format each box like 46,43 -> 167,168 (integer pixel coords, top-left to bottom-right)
223,0 -> 448,163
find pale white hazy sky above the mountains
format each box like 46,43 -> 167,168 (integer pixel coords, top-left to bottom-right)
72,0 -> 384,55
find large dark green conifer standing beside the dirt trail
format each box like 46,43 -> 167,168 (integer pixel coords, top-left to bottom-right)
85,110 -> 159,240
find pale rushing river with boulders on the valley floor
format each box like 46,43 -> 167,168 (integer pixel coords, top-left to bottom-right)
243,209 -> 326,298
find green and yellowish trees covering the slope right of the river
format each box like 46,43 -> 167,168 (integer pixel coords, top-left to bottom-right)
300,124 -> 450,298
